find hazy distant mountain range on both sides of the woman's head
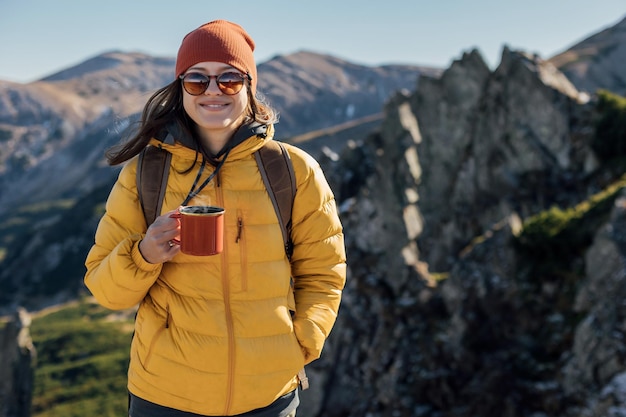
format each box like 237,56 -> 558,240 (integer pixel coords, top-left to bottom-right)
0,51 -> 434,213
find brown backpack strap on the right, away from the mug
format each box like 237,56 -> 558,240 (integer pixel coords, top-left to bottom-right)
254,140 -> 296,259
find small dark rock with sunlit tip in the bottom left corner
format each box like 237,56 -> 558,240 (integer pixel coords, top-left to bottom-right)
0,309 -> 37,417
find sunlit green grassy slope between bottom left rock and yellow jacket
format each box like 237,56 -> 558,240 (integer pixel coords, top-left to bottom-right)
31,300 -> 134,417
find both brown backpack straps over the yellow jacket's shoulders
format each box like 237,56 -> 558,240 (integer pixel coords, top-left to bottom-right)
137,140 -> 296,259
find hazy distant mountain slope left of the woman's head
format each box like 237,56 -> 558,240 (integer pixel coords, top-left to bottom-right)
0,52 -> 179,213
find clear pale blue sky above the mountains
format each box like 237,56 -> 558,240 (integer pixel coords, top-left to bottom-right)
0,0 -> 626,82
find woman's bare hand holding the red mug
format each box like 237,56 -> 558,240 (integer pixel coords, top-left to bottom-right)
139,210 -> 180,264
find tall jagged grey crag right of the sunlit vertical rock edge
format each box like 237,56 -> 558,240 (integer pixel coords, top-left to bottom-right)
412,48 -> 597,271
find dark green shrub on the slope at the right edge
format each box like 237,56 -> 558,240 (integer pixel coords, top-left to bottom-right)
591,90 -> 626,162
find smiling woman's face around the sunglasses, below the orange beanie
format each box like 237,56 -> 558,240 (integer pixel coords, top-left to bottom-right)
183,62 -> 248,139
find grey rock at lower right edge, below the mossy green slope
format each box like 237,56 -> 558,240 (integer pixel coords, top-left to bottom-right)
562,191 -> 626,417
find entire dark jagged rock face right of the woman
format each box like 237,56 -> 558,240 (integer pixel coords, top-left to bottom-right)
296,49 -> 626,417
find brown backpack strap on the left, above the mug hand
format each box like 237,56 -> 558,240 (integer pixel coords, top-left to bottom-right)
137,146 -> 172,226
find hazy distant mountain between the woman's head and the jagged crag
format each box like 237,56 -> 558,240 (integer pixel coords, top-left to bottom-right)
258,51 -> 442,137
